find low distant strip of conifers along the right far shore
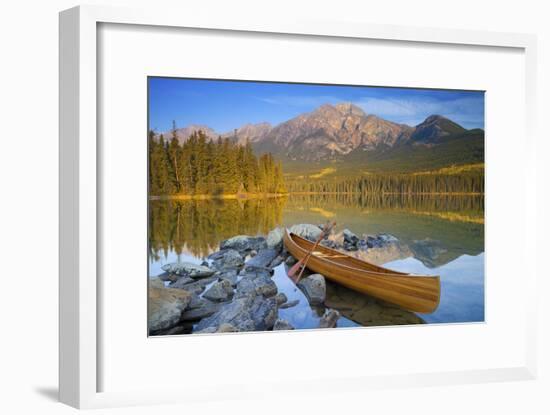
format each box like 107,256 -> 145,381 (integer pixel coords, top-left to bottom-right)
287,172 -> 485,194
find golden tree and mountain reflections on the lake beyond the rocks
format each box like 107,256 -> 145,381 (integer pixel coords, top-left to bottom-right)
149,194 -> 484,268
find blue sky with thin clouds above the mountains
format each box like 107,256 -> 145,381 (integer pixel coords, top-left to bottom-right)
149,77 -> 484,133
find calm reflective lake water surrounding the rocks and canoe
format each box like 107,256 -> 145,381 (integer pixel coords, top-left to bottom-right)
149,194 -> 484,328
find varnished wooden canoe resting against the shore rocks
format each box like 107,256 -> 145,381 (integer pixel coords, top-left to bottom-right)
283,230 -> 441,313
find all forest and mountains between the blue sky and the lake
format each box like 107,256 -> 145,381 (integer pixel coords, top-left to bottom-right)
149,103 -> 485,197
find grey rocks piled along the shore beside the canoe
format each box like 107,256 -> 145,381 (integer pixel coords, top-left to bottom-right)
148,224 -> 421,335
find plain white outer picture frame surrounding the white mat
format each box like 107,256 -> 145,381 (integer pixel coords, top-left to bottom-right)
59,6 -> 537,408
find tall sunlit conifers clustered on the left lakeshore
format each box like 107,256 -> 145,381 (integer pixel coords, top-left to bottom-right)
149,125 -> 286,196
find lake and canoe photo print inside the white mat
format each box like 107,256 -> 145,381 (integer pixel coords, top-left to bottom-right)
148,76 -> 485,335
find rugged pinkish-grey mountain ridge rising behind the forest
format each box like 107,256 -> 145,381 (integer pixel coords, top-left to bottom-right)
156,103 -> 484,167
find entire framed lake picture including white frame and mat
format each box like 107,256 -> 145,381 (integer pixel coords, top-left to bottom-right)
60,6 -> 536,408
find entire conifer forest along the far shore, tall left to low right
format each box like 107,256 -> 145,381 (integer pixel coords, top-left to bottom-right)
149,128 -> 485,197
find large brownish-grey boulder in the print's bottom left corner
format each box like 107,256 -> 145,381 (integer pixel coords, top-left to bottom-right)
147,287 -> 191,333
